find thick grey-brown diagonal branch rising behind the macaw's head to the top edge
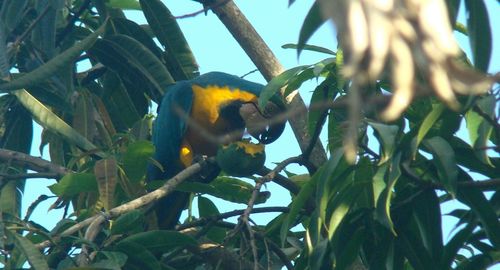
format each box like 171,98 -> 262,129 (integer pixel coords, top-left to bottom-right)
212,0 -> 326,170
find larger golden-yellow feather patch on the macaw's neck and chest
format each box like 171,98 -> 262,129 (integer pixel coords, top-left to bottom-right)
191,85 -> 257,124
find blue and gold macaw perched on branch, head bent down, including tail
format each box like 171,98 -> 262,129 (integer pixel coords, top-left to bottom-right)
148,72 -> 285,229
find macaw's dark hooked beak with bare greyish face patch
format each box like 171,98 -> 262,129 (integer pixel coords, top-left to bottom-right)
240,102 -> 285,144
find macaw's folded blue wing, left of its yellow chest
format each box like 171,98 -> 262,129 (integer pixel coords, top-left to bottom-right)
148,81 -> 193,181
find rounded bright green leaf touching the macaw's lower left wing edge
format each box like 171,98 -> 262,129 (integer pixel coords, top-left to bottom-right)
123,141 -> 155,183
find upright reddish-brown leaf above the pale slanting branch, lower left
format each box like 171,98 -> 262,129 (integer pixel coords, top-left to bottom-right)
94,157 -> 118,211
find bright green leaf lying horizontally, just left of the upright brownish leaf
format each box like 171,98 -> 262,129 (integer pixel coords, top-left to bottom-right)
49,173 -> 97,198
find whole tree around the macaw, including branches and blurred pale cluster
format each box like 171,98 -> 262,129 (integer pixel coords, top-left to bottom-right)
0,0 -> 500,269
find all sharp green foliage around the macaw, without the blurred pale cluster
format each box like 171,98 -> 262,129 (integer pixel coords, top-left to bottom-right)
0,0 -> 500,269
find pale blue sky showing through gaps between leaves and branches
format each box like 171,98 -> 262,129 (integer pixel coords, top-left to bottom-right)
23,0 -> 500,262
